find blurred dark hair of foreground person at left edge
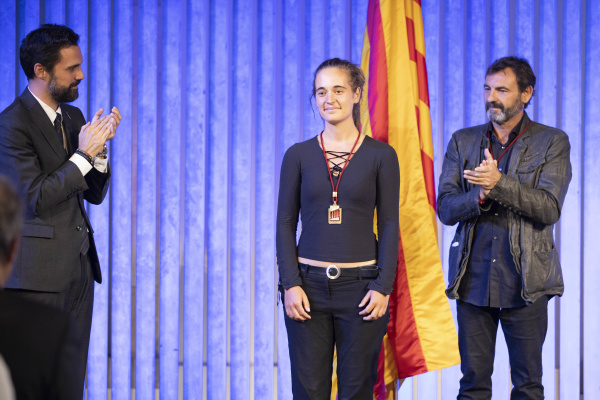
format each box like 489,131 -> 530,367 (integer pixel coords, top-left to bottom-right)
0,175 -> 23,263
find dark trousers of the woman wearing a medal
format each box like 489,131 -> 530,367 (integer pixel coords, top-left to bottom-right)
282,270 -> 389,400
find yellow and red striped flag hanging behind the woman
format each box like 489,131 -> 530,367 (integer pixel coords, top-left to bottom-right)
361,0 -> 460,400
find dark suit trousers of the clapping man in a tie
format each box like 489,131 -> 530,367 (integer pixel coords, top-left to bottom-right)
6,250 -> 94,399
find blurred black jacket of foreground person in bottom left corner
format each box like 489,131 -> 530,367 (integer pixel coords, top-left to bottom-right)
0,290 -> 82,400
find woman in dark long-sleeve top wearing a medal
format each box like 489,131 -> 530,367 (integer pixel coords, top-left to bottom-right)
277,58 -> 400,400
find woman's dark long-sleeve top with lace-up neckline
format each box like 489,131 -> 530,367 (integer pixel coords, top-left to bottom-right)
277,136 -> 400,295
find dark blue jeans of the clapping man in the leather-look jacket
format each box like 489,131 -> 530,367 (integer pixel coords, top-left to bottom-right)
456,296 -> 548,400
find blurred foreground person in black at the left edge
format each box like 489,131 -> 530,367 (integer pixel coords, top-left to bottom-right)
0,177 -> 81,400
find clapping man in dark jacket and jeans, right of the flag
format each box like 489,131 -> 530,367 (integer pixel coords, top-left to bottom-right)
438,57 -> 571,399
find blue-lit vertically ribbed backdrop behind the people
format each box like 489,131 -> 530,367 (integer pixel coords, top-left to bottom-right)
0,0 -> 600,400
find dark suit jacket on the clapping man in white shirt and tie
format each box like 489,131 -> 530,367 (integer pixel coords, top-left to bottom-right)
0,88 -> 110,292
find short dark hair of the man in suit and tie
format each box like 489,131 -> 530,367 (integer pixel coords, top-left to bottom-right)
20,24 -> 79,80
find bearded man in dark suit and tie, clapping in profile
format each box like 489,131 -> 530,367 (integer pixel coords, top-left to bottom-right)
0,25 -> 121,393
